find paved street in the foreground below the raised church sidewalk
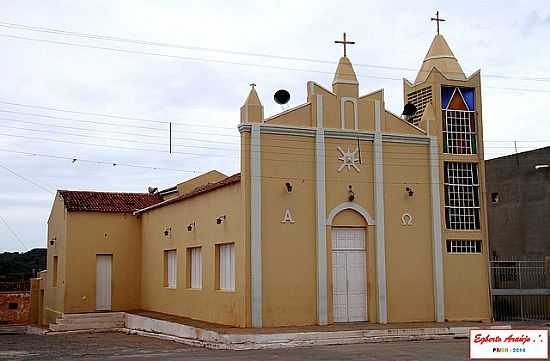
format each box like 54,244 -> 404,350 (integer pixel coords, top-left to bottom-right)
0,333 -> 474,361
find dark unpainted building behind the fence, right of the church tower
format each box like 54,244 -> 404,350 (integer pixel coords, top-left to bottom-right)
485,147 -> 550,261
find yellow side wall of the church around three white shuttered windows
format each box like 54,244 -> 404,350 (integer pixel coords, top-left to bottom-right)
140,183 -> 248,327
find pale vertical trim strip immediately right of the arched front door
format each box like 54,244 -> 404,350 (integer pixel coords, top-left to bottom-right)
374,100 -> 388,323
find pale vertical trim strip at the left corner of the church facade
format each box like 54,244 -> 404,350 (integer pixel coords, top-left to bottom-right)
250,124 -> 262,327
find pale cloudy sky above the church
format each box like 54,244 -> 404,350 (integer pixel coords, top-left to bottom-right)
0,0 -> 550,252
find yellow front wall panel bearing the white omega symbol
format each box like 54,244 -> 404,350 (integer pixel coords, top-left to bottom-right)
383,142 -> 435,322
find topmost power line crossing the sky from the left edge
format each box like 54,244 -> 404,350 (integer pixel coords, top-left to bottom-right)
0,21 -> 550,82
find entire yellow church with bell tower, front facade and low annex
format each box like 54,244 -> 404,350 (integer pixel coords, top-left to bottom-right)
42,28 -> 496,327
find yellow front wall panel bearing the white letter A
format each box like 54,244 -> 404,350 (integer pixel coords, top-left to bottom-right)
261,134 -> 317,327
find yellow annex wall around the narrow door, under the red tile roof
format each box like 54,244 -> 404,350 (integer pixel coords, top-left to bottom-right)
64,212 -> 141,313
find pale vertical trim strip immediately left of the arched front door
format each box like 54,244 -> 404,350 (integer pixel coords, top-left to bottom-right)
315,95 -> 328,325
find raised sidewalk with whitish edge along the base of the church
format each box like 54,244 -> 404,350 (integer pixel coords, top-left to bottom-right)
124,310 -> 511,350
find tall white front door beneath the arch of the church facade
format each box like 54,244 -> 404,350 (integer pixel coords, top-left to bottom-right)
332,228 -> 367,322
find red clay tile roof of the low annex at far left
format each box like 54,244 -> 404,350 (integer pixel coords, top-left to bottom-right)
58,190 -> 162,212
